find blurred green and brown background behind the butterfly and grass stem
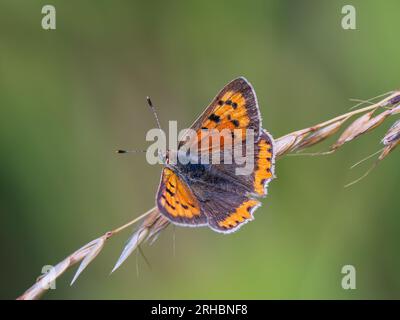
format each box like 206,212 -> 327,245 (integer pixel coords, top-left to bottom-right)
0,0 -> 400,299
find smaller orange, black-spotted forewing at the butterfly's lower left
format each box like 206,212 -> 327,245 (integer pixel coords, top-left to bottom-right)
157,168 -> 207,226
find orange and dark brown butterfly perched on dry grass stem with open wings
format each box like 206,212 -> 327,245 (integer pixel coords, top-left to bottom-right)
156,77 -> 275,233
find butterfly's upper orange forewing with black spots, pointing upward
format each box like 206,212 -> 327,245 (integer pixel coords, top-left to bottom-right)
180,77 -> 261,149
